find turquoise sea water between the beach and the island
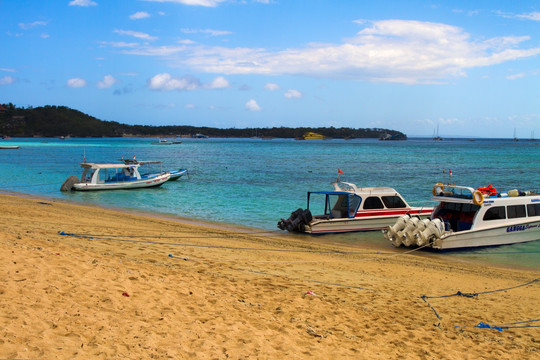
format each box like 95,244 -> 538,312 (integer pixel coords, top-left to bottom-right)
0,138 -> 540,269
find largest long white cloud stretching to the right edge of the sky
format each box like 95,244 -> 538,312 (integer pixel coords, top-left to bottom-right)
130,20 -> 540,84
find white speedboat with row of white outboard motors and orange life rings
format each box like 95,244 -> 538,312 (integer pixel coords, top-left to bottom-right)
384,183 -> 540,249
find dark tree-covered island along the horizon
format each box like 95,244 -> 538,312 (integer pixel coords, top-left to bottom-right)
0,103 -> 407,140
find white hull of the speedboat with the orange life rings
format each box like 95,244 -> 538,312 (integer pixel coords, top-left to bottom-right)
431,220 -> 540,250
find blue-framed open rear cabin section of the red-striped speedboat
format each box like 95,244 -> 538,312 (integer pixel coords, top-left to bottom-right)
307,191 -> 362,219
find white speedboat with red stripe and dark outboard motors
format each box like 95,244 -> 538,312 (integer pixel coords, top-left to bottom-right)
278,181 -> 433,234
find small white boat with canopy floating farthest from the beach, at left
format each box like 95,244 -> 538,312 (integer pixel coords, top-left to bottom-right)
61,162 -> 171,191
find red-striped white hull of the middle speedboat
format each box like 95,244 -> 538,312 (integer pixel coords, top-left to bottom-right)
305,211 -> 431,234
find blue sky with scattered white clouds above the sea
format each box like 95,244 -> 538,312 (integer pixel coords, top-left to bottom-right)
0,0 -> 540,138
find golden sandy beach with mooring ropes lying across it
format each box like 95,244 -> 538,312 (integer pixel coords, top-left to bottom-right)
0,194 -> 540,359
